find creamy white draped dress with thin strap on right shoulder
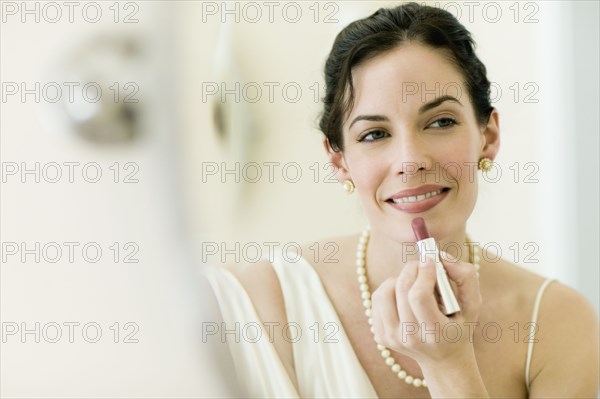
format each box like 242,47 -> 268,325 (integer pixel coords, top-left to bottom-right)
205,251 -> 553,398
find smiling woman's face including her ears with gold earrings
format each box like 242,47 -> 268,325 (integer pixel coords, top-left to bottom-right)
329,43 -> 499,242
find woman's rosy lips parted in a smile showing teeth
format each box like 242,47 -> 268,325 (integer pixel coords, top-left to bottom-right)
386,184 -> 450,213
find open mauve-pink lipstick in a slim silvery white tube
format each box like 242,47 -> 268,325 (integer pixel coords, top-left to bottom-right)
411,218 -> 460,316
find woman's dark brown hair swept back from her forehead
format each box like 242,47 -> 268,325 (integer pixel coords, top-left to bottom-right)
319,3 -> 493,151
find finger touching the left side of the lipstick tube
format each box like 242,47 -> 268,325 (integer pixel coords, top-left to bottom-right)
408,256 -> 446,324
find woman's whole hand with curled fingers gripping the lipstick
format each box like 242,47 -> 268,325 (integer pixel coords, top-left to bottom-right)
372,253 -> 481,366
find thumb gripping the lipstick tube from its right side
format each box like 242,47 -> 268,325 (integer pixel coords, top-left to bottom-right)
440,253 -> 481,319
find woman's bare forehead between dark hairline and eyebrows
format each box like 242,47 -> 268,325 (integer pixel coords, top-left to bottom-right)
349,43 -> 469,117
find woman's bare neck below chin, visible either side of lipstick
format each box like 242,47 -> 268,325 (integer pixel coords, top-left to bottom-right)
366,229 -> 469,291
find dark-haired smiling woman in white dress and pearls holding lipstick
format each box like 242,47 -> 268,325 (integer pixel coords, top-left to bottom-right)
207,3 -> 598,398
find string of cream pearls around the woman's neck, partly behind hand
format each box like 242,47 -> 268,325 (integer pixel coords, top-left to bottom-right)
356,226 -> 480,388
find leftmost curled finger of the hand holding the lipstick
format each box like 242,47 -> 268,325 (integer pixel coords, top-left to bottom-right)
371,278 -> 399,345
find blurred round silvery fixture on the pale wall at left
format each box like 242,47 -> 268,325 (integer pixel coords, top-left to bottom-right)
61,34 -> 149,144
